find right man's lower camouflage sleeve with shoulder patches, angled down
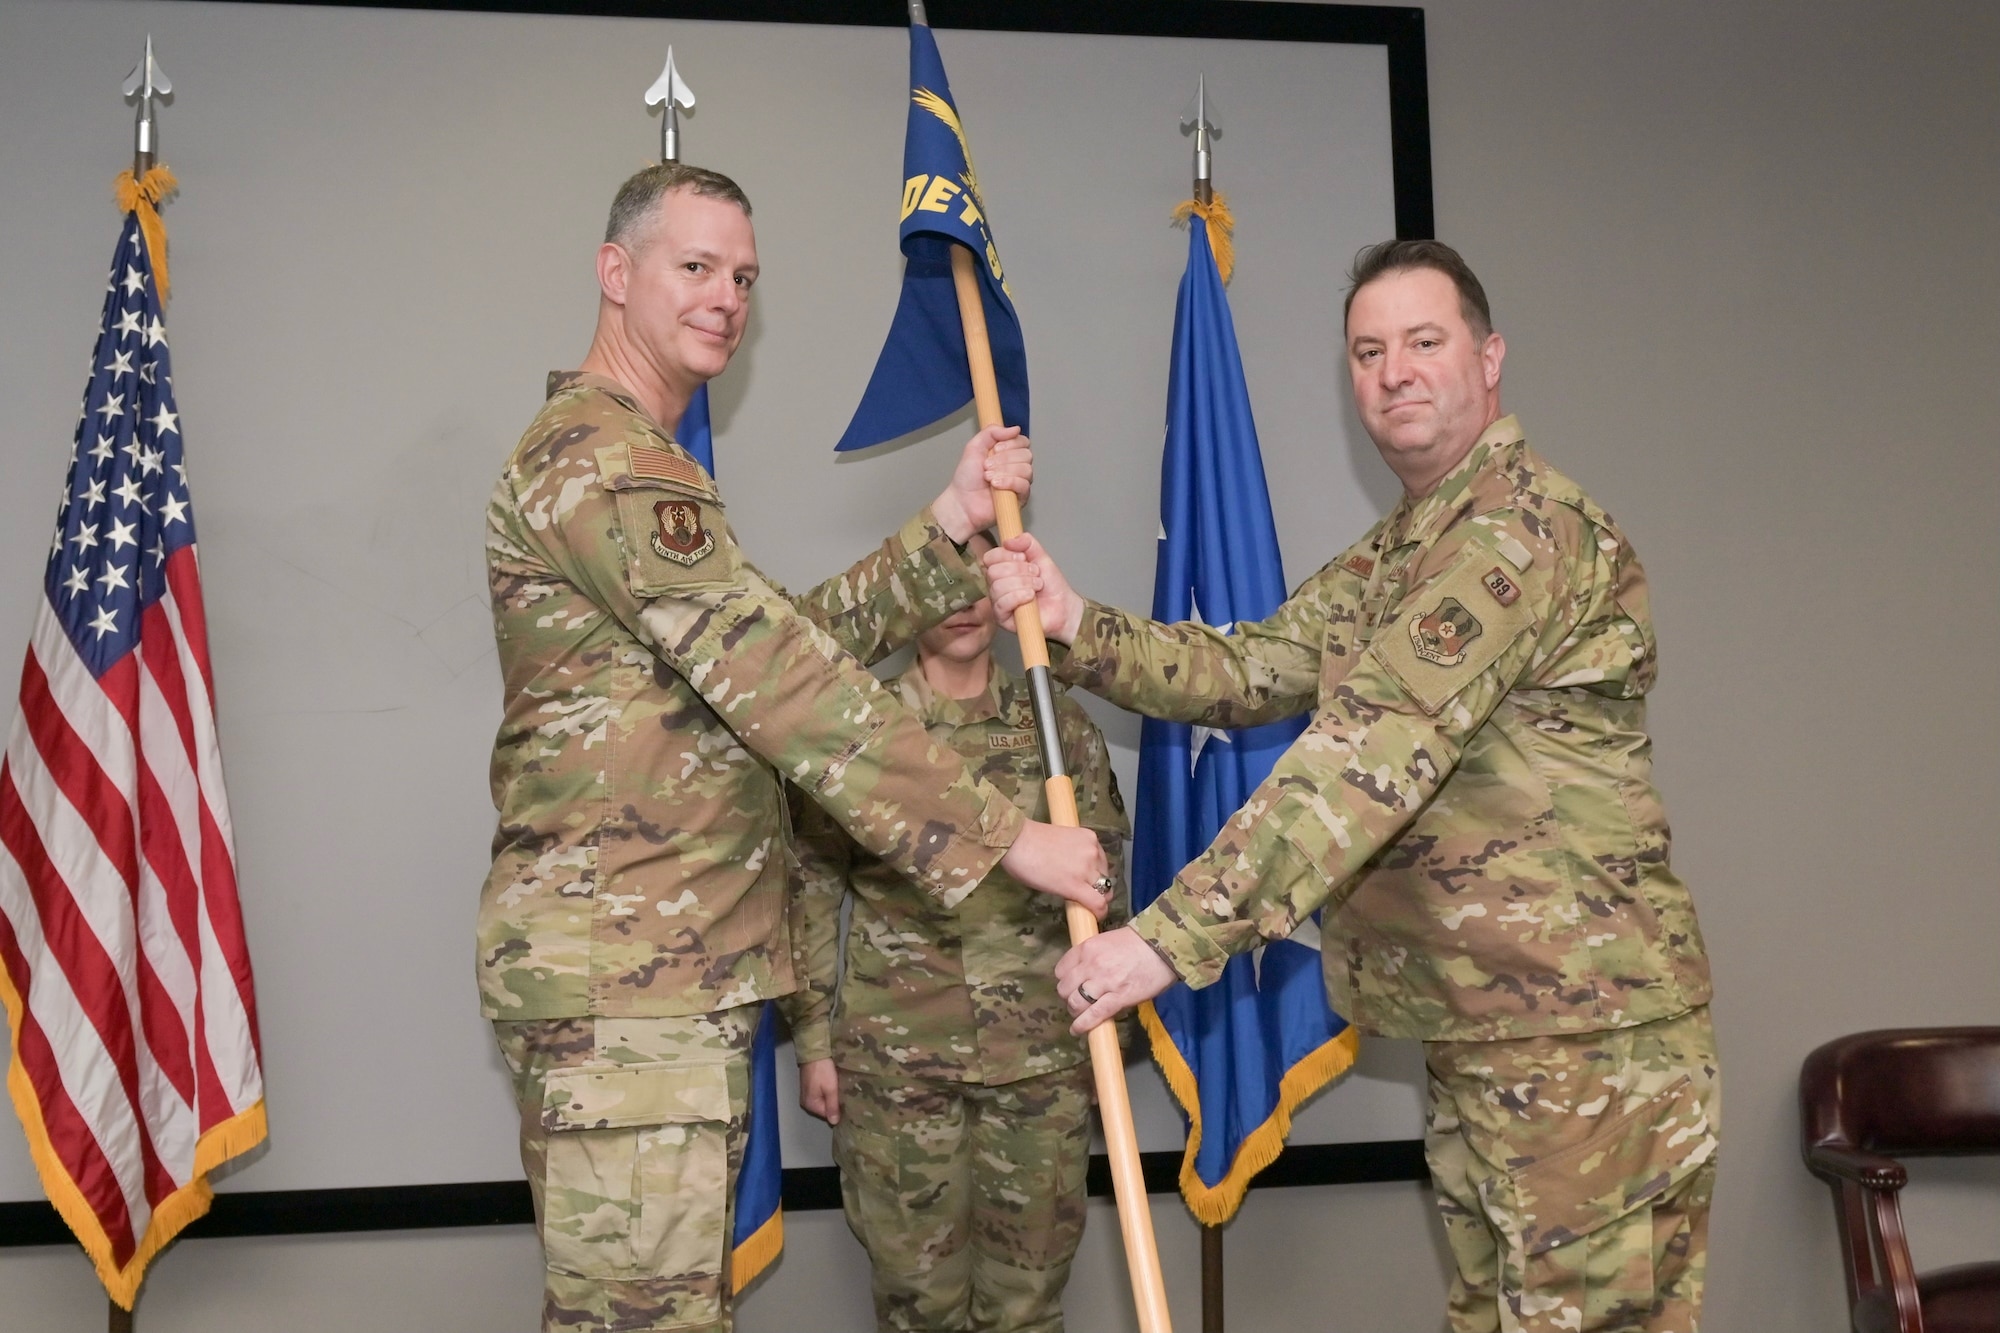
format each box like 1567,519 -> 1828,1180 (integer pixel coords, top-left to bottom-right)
1132,510 -> 1574,987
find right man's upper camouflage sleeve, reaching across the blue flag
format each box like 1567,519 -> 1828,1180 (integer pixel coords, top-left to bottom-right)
1056,566 -> 1332,729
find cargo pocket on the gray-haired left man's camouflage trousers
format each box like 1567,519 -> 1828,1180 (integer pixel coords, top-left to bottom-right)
542,1063 -> 730,1313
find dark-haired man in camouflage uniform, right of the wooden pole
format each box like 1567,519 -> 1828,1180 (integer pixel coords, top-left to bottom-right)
988,240 -> 1720,1333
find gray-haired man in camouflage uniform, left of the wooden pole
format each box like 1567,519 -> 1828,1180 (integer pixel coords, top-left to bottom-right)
478,164 -> 1104,1333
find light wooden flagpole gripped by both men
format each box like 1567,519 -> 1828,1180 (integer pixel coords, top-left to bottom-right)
952,244 -> 1174,1333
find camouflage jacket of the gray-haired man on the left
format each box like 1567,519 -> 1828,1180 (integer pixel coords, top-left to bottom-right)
478,372 -> 1022,1019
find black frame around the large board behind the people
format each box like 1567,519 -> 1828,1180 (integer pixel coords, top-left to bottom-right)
0,0 -> 1436,1249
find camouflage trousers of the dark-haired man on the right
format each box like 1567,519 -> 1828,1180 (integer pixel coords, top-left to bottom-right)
1424,1007 -> 1722,1333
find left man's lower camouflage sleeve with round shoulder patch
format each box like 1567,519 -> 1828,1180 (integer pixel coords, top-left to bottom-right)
522,442 -> 1024,905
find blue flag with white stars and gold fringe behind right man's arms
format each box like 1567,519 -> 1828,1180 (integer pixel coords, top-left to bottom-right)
1132,194 -> 1356,1225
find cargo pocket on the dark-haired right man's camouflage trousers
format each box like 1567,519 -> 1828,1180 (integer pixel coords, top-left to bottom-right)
1506,1075 -> 1716,1331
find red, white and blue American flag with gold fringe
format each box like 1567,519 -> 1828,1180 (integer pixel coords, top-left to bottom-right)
0,212 -> 264,1307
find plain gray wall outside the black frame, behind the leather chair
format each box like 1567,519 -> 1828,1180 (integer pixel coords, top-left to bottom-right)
0,0 -> 2000,1333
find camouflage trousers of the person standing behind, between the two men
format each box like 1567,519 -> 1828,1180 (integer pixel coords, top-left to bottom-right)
834,1065 -> 1090,1333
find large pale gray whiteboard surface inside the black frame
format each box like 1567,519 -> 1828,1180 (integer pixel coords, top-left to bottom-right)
0,0 -> 1422,1201
